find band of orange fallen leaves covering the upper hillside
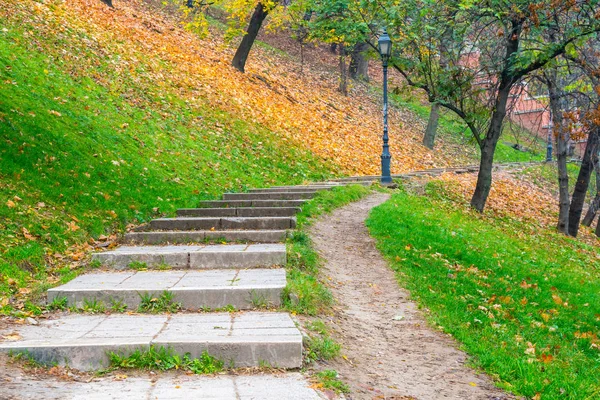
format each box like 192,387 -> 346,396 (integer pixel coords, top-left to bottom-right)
0,0 -> 460,175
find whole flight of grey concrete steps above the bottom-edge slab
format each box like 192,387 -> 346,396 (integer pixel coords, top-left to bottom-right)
0,182 -> 358,376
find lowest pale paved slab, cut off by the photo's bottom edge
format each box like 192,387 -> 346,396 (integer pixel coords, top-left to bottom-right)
0,372 -> 328,400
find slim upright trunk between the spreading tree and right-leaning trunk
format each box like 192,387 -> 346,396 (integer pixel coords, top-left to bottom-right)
546,70 -> 571,234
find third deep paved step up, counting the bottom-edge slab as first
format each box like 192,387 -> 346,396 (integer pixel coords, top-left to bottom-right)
48,269 -> 286,310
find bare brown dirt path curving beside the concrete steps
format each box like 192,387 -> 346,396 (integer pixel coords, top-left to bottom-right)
311,194 -> 513,400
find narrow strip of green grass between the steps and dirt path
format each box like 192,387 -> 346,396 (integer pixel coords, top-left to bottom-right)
283,185 -> 370,315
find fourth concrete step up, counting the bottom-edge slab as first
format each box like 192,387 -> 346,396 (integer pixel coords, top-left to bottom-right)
92,244 -> 286,269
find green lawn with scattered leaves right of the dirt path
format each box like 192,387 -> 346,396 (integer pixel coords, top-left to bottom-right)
367,184 -> 600,399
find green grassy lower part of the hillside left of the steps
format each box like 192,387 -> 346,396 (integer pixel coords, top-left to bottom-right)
0,9 -> 335,313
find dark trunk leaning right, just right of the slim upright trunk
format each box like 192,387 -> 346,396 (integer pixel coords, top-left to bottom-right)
569,126 -> 600,237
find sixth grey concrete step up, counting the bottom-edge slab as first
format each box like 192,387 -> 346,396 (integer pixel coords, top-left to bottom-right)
142,217 -> 296,231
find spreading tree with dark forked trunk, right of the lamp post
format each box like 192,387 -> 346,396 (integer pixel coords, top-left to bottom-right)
368,0 -> 600,211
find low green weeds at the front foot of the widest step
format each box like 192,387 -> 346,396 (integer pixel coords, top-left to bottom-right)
108,346 -> 223,374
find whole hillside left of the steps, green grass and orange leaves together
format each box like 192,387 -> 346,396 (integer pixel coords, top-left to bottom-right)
0,0 -> 544,307
